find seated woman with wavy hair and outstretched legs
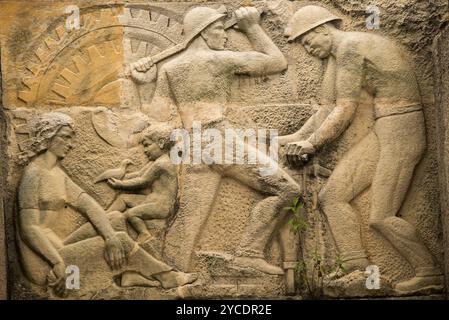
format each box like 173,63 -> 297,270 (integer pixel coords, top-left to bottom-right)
18,112 -> 196,296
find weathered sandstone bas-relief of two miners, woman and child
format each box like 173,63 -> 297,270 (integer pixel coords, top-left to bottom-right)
0,0 -> 444,299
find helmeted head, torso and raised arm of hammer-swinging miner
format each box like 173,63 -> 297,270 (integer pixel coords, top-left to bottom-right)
144,7 -> 287,129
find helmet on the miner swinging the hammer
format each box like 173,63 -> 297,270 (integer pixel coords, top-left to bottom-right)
183,6 -> 226,39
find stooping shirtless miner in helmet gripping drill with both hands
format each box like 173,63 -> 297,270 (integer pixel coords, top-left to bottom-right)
279,6 -> 443,293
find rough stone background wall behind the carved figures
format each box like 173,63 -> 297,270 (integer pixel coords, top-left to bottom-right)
0,0 -> 449,299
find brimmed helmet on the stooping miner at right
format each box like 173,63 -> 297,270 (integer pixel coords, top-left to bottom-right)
285,6 -> 341,42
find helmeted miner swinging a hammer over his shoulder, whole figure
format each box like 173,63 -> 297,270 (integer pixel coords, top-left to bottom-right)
136,7 -> 300,275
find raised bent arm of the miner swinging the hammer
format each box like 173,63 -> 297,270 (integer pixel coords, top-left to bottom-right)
230,7 -> 287,76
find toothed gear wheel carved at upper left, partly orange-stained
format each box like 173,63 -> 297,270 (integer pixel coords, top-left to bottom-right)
17,7 -> 182,106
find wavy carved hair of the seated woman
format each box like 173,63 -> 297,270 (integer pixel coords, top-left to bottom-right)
19,112 -> 74,164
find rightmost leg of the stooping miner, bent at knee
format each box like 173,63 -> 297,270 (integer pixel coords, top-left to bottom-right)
370,112 -> 441,291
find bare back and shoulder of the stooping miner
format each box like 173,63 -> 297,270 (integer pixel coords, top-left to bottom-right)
336,32 -> 420,105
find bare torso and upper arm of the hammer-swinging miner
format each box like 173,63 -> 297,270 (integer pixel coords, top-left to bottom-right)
152,44 -> 283,128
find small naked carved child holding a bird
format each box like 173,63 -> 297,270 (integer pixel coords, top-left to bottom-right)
108,123 -> 178,243
